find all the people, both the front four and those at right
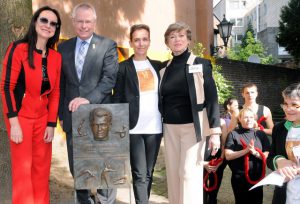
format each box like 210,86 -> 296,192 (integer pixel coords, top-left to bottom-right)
1,3 -> 300,204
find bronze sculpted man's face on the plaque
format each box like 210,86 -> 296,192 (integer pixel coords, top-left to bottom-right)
90,108 -> 112,141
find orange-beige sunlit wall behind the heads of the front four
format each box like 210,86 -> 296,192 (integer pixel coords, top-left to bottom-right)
32,0 -> 213,59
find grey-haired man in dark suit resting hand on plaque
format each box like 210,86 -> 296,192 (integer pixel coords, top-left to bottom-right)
58,3 -> 118,204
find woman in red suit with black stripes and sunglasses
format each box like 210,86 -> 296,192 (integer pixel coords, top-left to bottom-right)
1,6 -> 61,204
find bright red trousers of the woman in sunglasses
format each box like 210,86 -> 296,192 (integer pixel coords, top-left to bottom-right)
6,115 -> 52,204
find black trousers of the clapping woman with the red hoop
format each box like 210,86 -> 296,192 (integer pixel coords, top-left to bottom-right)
231,174 -> 263,204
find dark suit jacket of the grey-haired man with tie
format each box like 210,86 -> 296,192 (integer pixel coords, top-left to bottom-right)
58,34 -> 118,132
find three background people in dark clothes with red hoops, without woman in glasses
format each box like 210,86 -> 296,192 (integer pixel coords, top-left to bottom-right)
204,83 -> 273,204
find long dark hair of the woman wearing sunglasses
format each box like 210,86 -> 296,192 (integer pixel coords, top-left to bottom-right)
21,6 -> 61,68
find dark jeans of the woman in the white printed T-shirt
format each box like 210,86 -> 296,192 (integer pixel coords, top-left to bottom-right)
130,134 -> 162,204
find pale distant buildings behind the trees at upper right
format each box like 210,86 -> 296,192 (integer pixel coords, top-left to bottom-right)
214,0 -> 291,61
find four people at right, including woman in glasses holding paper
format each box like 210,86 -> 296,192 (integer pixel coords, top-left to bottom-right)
204,83 -> 300,204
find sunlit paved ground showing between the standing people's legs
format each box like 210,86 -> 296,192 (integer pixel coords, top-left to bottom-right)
50,132 -> 273,204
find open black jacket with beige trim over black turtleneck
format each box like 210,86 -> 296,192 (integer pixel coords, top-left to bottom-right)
160,53 -> 221,142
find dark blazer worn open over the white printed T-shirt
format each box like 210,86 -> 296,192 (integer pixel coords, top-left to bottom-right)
113,56 -> 161,129
